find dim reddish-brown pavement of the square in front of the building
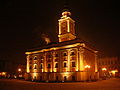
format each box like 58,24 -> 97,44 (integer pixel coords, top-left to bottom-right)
0,78 -> 120,90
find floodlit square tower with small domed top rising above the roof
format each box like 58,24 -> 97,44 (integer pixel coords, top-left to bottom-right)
58,10 -> 76,42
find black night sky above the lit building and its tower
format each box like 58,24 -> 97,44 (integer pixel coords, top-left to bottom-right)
0,0 -> 120,63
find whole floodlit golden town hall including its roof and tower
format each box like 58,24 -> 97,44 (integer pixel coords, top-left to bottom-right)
25,11 -> 98,81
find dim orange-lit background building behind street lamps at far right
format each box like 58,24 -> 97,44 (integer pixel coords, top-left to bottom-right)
98,57 -> 120,77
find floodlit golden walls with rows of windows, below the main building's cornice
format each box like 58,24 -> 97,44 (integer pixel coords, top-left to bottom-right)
27,46 -> 95,81
